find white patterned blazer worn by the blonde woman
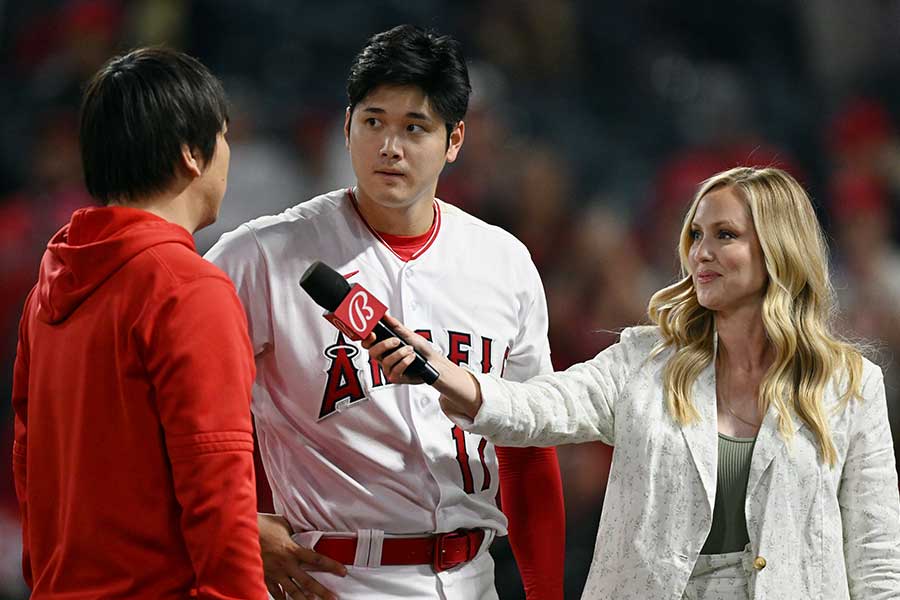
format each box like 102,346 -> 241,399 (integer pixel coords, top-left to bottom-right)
451,327 -> 900,600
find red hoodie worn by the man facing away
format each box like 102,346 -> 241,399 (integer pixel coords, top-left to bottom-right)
13,207 -> 267,600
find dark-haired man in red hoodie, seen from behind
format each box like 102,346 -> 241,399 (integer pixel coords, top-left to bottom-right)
13,48 -> 267,600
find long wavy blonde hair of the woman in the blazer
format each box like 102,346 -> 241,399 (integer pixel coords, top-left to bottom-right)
647,167 -> 862,466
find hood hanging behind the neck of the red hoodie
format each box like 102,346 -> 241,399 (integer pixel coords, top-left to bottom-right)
37,206 -> 196,323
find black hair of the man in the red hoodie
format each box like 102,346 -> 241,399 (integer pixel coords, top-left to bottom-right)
80,47 -> 228,204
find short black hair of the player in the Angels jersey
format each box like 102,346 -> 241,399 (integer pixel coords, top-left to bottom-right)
347,25 -> 472,144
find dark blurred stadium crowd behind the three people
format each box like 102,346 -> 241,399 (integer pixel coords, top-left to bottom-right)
0,0 -> 900,599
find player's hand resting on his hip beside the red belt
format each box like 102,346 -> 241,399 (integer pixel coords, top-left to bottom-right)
257,513 -> 347,600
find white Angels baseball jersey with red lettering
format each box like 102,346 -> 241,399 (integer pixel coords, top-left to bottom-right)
206,190 -> 552,535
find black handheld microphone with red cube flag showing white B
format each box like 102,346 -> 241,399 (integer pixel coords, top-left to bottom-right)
300,261 -> 440,384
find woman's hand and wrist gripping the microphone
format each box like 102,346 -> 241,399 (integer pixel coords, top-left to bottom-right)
362,314 -> 481,419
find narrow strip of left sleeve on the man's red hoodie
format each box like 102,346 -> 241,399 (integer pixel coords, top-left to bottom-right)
12,290 -> 34,587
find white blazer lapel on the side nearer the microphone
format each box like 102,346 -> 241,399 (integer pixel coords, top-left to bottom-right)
681,361 -> 719,515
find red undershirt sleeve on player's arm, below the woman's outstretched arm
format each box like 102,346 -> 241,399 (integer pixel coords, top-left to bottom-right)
497,446 -> 566,600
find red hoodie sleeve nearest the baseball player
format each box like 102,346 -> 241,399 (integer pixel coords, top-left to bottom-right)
142,276 -> 267,600
